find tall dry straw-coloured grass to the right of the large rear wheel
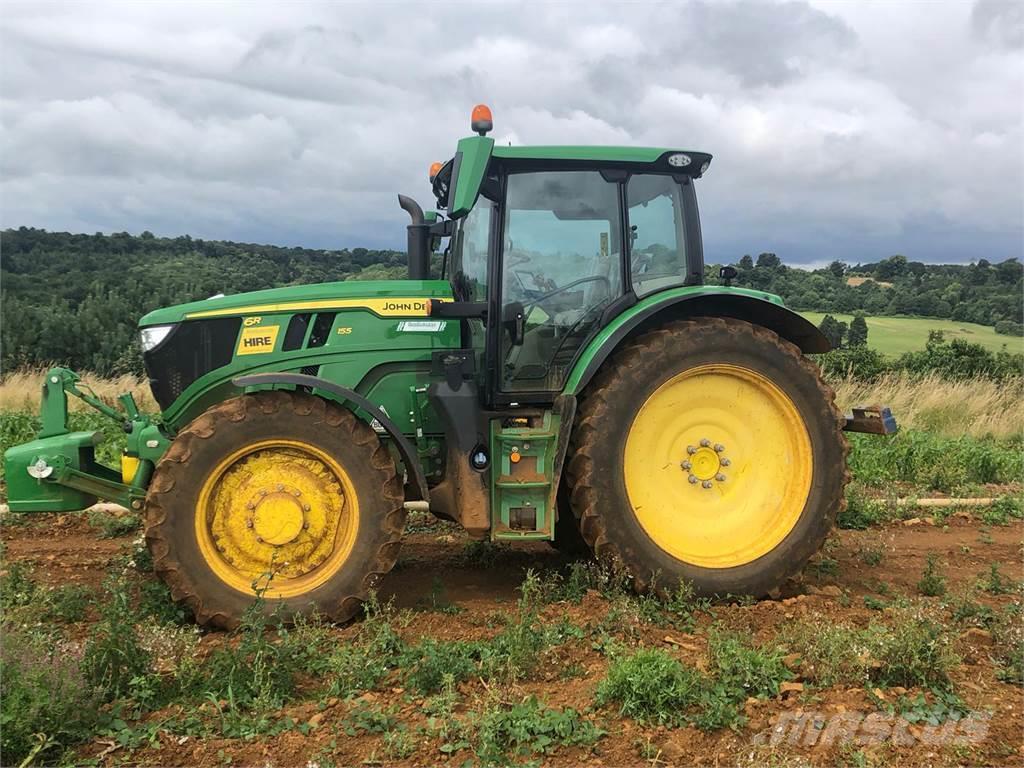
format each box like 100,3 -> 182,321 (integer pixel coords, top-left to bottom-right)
830,373 -> 1024,438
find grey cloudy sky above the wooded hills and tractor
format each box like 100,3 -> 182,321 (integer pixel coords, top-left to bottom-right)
0,0 -> 1024,263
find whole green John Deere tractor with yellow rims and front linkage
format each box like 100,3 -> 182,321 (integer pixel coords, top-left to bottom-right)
5,105 -> 895,628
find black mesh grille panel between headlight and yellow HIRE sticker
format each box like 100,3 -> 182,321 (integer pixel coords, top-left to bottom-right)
142,317 -> 242,411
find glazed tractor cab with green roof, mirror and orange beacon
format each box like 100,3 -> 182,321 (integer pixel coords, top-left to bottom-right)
417,108 -> 711,407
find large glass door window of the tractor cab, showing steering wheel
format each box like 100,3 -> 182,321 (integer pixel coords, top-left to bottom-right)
501,171 -> 623,391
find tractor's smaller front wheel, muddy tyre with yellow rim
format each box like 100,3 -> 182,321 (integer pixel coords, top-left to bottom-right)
145,392 -> 406,628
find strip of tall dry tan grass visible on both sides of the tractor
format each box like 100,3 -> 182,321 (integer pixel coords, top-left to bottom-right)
0,370 -> 1024,438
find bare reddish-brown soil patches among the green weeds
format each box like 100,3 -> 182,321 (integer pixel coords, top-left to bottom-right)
2,515 -> 1024,768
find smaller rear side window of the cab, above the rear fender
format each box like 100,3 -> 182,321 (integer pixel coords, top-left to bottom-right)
626,174 -> 687,296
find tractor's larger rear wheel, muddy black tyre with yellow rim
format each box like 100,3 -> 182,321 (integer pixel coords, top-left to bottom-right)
568,317 -> 849,595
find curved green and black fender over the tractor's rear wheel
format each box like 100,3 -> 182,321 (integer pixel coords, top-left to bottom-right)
565,286 -> 831,395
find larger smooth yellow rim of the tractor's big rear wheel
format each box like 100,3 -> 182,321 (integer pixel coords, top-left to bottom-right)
624,365 -> 813,568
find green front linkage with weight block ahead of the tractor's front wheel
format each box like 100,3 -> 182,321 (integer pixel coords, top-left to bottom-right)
4,368 -> 170,512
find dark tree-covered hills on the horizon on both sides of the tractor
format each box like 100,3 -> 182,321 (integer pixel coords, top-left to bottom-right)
0,227 -> 1024,374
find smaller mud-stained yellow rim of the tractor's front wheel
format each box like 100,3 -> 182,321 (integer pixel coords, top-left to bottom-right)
196,440 -> 359,598
